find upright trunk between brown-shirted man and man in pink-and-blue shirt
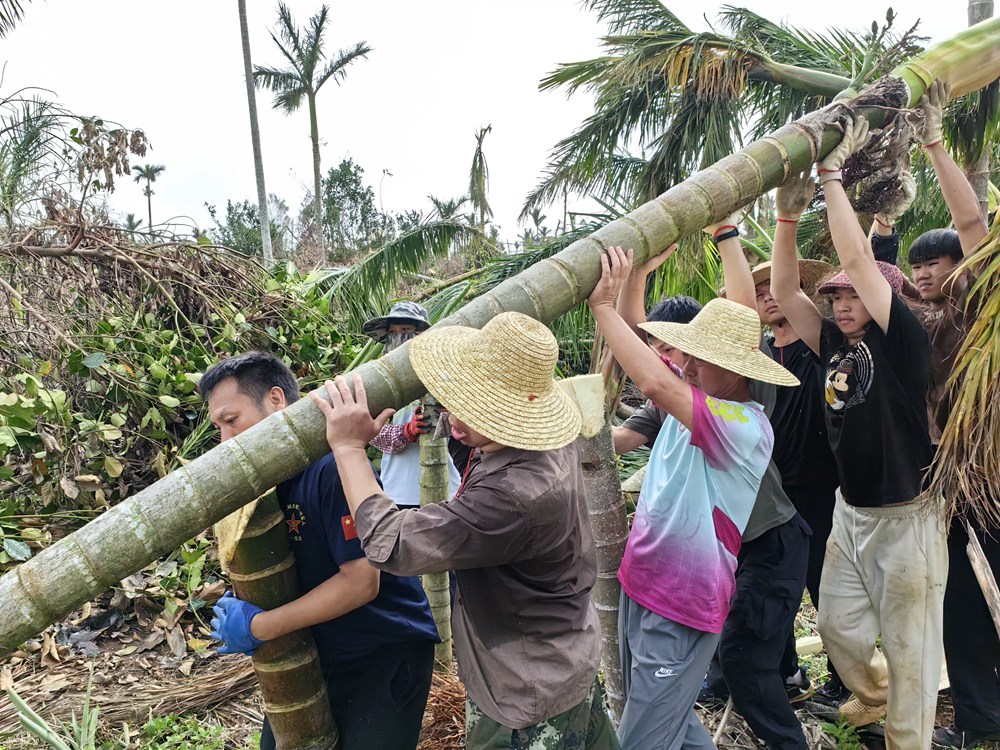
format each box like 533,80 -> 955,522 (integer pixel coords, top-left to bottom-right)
577,421 -> 628,725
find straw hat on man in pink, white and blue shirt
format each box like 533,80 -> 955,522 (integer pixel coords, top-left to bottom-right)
639,298 -> 799,385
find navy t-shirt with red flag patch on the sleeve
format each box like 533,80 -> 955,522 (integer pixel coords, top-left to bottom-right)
277,453 -> 438,668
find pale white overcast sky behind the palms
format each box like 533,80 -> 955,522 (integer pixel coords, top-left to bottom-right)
0,0 -> 980,239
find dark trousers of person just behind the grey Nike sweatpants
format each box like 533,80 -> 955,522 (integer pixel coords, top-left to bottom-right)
719,515 -> 809,750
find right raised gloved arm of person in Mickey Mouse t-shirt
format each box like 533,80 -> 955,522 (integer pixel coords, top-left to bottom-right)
820,117 -> 892,331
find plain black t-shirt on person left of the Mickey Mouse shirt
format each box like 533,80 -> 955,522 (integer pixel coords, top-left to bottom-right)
767,337 -> 840,488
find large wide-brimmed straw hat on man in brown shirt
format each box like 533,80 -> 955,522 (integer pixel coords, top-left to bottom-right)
410,312 -> 581,451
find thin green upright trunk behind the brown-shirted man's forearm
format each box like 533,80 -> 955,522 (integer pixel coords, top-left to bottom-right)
420,396 -> 454,673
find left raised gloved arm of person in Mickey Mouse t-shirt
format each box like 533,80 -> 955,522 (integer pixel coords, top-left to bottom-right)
771,172 -> 823,354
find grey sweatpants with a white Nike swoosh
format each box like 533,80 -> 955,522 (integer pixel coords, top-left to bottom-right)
618,590 -> 719,750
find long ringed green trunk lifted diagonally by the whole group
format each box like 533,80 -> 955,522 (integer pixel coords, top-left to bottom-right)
0,19 -> 1000,658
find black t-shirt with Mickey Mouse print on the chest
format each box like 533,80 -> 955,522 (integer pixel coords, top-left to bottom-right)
820,294 -> 931,508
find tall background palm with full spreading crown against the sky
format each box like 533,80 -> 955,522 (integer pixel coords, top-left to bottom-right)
253,3 -> 371,248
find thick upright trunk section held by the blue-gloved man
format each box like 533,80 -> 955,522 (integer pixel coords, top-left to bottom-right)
229,492 -> 339,750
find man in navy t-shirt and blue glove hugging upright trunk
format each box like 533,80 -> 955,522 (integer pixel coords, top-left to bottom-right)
199,352 -> 438,750
